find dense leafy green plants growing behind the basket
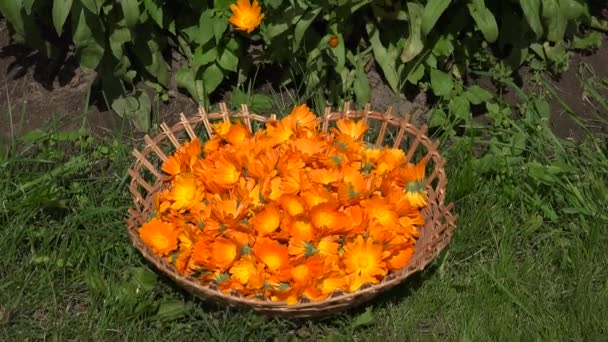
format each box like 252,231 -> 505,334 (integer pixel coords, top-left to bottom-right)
0,0 -> 597,129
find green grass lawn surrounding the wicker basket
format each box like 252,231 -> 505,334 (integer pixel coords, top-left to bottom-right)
0,79 -> 608,341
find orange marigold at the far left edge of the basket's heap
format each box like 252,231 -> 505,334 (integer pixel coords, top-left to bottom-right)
139,217 -> 178,256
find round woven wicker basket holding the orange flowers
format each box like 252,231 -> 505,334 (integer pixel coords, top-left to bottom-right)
127,103 -> 456,318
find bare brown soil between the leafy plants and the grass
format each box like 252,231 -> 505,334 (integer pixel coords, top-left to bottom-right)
0,17 -> 608,145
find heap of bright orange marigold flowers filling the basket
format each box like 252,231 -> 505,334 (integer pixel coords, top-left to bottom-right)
139,105 -> 427,304
